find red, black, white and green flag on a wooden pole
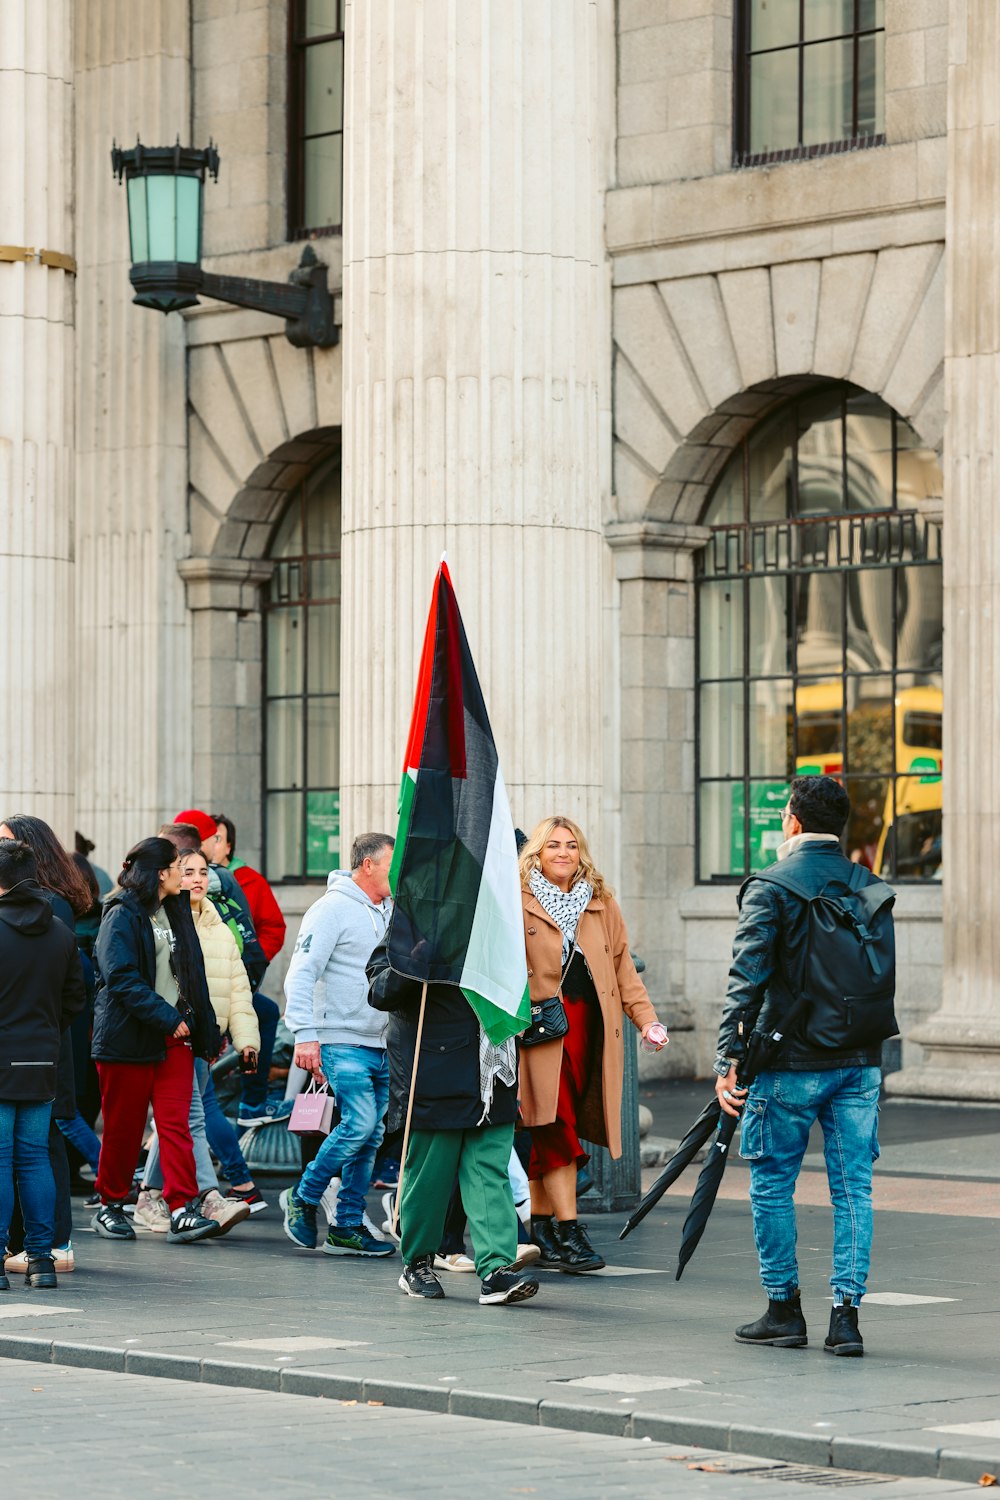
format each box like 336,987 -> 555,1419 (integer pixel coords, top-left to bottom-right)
387,560 -> 531,1044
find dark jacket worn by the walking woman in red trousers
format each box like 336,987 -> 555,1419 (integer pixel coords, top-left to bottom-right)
91,891 -> 220,1062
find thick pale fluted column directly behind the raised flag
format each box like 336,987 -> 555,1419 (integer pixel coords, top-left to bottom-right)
342,0 -> 609,858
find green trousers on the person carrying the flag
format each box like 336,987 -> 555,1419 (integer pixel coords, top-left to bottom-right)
399,1124 -> 517,1278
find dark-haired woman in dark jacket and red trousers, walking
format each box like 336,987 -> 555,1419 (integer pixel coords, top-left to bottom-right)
91,839 -> 220,1242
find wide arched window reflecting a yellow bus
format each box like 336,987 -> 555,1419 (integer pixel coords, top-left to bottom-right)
696,384 -> 943,881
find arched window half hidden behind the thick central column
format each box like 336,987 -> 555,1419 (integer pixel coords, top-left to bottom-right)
264,456 -> 340,881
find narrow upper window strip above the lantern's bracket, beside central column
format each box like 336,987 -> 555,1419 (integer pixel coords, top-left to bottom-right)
288,0 -> 345,240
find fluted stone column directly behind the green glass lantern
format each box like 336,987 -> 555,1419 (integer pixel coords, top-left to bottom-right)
75,0 -> 193,869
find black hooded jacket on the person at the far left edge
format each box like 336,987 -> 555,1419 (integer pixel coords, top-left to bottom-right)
0,881 -> 85,1103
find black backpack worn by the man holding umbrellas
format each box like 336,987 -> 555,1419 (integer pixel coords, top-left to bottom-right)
741,861 -> 900,1052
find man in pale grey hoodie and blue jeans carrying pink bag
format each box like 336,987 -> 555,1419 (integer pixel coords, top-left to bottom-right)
280,834 -> 394,1256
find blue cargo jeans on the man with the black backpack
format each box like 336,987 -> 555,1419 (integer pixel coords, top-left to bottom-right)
739,1068 -> 882,1302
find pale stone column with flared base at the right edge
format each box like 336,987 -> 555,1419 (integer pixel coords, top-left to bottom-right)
888,0 -> 1000,1100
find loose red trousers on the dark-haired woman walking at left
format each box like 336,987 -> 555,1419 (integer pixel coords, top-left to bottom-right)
97,1037 -> 198,1209
